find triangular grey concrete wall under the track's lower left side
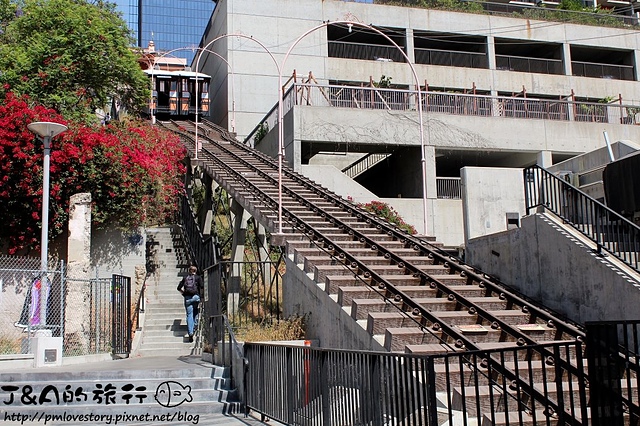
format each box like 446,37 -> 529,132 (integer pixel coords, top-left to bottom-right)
282,248 -> 384,351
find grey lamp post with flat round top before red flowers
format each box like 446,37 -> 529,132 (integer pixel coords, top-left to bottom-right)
27,121 -> 67,326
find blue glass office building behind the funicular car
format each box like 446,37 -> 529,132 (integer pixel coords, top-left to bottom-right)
115,0 -> 215,64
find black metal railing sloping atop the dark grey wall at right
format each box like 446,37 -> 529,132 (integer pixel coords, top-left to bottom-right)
524,166 -> 640,270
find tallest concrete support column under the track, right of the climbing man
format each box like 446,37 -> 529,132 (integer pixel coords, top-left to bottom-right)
227,200 -> 250,316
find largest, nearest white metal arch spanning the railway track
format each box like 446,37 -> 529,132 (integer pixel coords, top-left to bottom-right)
278,20 -> 427,236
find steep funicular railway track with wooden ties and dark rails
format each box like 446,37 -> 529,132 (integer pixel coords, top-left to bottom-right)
161,122 -> 624,424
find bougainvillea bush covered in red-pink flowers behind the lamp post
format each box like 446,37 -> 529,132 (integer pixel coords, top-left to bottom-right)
0,91 -> 185,254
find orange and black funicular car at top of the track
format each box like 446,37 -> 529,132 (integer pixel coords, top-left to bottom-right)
144,69 -> 211,117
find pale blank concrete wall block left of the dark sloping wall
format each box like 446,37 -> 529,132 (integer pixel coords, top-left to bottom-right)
460,167 -> 525,244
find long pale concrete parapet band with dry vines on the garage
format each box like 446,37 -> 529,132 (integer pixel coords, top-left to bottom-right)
295,106 -> 640,158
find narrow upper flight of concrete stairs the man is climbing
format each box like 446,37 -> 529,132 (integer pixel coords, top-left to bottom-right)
132,227 -> 201,356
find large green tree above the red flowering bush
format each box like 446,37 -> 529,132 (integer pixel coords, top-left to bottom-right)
0,0 -> 149,121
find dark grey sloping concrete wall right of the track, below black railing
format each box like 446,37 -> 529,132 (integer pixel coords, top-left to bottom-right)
466,214 -> 640,323
